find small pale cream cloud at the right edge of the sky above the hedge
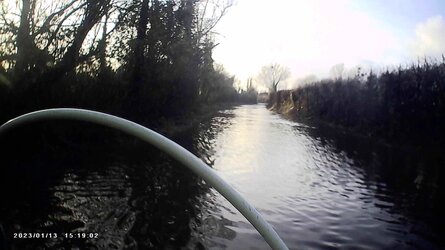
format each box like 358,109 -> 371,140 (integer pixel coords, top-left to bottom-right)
413,16 -> 445,57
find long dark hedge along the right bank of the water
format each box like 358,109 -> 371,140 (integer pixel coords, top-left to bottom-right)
271,60 -> 445,145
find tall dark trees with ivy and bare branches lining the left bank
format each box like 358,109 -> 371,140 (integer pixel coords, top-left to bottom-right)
0,0 -> 256,126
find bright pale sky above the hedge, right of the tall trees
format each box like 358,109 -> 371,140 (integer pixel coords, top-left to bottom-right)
213,0 -> 445,88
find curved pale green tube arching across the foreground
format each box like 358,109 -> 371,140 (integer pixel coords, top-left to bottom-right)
0,108 -> 288,249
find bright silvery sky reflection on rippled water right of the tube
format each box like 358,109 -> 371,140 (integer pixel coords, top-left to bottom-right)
186,104 -> 442,249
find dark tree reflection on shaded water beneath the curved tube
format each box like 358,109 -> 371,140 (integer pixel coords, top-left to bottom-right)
0,124 -> 209,249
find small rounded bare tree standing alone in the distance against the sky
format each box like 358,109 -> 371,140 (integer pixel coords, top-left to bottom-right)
258,63 -> 290,92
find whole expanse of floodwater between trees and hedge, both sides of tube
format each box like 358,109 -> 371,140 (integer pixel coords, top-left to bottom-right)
0,104 -> 445,249
